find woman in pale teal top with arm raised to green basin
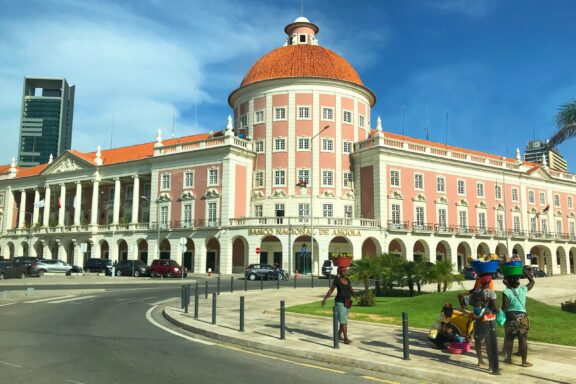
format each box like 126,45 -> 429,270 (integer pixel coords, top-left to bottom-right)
502,266 -> 535,367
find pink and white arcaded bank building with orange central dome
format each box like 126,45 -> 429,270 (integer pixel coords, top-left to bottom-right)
0,17 -> 576,275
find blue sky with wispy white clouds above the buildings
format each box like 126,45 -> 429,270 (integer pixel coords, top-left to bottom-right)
0,0 -> 576,172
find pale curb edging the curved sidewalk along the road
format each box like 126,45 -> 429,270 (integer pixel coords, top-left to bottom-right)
162,307 -> 502,384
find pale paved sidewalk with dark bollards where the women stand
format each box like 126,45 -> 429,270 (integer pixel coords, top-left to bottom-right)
164,287 -> 576,384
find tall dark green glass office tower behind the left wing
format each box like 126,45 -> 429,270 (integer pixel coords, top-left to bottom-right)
18,77 -> 74,167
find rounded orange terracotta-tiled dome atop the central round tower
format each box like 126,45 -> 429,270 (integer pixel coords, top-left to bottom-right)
240,44 -> 364,87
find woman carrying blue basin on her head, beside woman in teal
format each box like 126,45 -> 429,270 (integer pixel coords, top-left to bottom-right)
458,274 -> 498,368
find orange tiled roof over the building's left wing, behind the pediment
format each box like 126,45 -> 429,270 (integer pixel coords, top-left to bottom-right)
9,133 -> 209,178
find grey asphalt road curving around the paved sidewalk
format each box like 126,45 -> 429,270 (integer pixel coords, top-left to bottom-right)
0,281 -> 415,384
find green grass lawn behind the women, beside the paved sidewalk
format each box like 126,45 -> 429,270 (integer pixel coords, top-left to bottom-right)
286,291 -> 576,346
